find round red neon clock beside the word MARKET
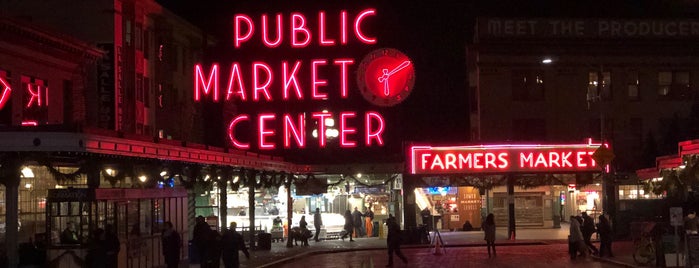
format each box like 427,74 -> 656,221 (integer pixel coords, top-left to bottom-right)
357,48 -> 415,107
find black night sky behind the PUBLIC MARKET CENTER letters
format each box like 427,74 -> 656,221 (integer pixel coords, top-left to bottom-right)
157,0 -> 696,163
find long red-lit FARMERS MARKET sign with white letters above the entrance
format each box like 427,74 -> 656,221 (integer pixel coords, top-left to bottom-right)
408,143 -> 601,174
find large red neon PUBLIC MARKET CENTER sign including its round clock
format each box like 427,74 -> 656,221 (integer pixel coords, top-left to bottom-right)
193,9 -> 414,150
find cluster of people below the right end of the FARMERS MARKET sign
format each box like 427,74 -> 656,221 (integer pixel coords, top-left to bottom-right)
568,212 -> 614,259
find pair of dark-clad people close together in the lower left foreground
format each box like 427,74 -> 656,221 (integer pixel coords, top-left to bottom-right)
194,216 -> 250,268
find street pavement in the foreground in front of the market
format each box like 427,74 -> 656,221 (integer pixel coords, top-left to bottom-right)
190,225 -> 652,268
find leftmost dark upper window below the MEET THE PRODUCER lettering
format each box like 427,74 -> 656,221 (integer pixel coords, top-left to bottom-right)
512,70 -> 544,101
